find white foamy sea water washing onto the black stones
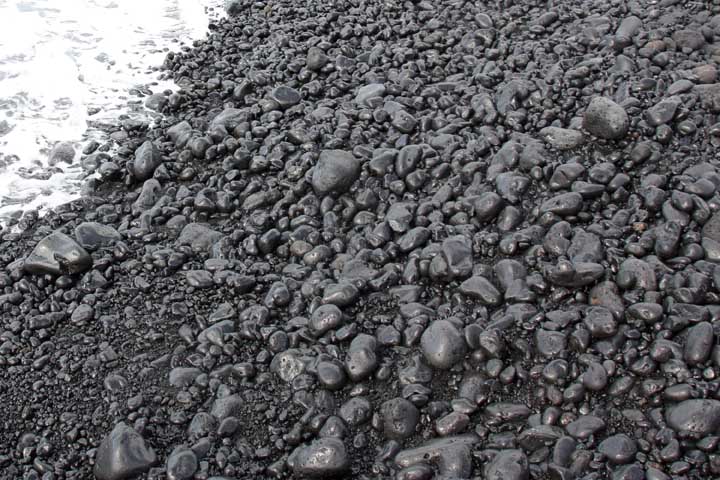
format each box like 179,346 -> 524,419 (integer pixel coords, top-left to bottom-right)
0,0 -> 222,222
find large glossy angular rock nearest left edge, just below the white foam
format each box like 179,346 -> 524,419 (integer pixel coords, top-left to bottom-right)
23,232 -> 93,275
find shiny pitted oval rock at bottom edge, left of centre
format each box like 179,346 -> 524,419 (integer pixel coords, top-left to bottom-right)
288,437 -> 350,478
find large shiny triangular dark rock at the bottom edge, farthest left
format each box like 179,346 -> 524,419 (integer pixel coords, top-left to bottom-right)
93,422 -> 157,480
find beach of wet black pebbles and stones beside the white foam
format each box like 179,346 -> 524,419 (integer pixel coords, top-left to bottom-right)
0,0 -> 720,480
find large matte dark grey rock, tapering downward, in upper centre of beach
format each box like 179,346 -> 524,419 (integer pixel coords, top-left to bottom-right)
312,150 -> 360,195
